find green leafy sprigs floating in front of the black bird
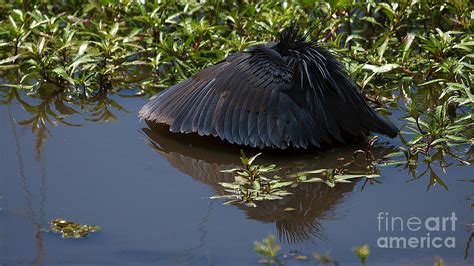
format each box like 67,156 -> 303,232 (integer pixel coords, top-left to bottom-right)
210,148 -> 386,208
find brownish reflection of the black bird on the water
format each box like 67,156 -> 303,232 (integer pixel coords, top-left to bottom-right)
142,122 -> 393,243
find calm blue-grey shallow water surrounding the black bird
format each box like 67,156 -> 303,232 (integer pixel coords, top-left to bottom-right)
0,96 -> 474,265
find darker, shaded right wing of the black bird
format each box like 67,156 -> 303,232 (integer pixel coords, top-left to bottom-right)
287,46 -> 398,144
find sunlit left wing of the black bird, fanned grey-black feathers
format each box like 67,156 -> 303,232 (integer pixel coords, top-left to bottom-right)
140,46 -> 319,148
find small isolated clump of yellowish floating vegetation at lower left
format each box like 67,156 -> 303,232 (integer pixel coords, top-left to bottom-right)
50,218 -> 100,238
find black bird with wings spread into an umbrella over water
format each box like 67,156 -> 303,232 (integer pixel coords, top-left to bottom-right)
140,25 -> 398,149
